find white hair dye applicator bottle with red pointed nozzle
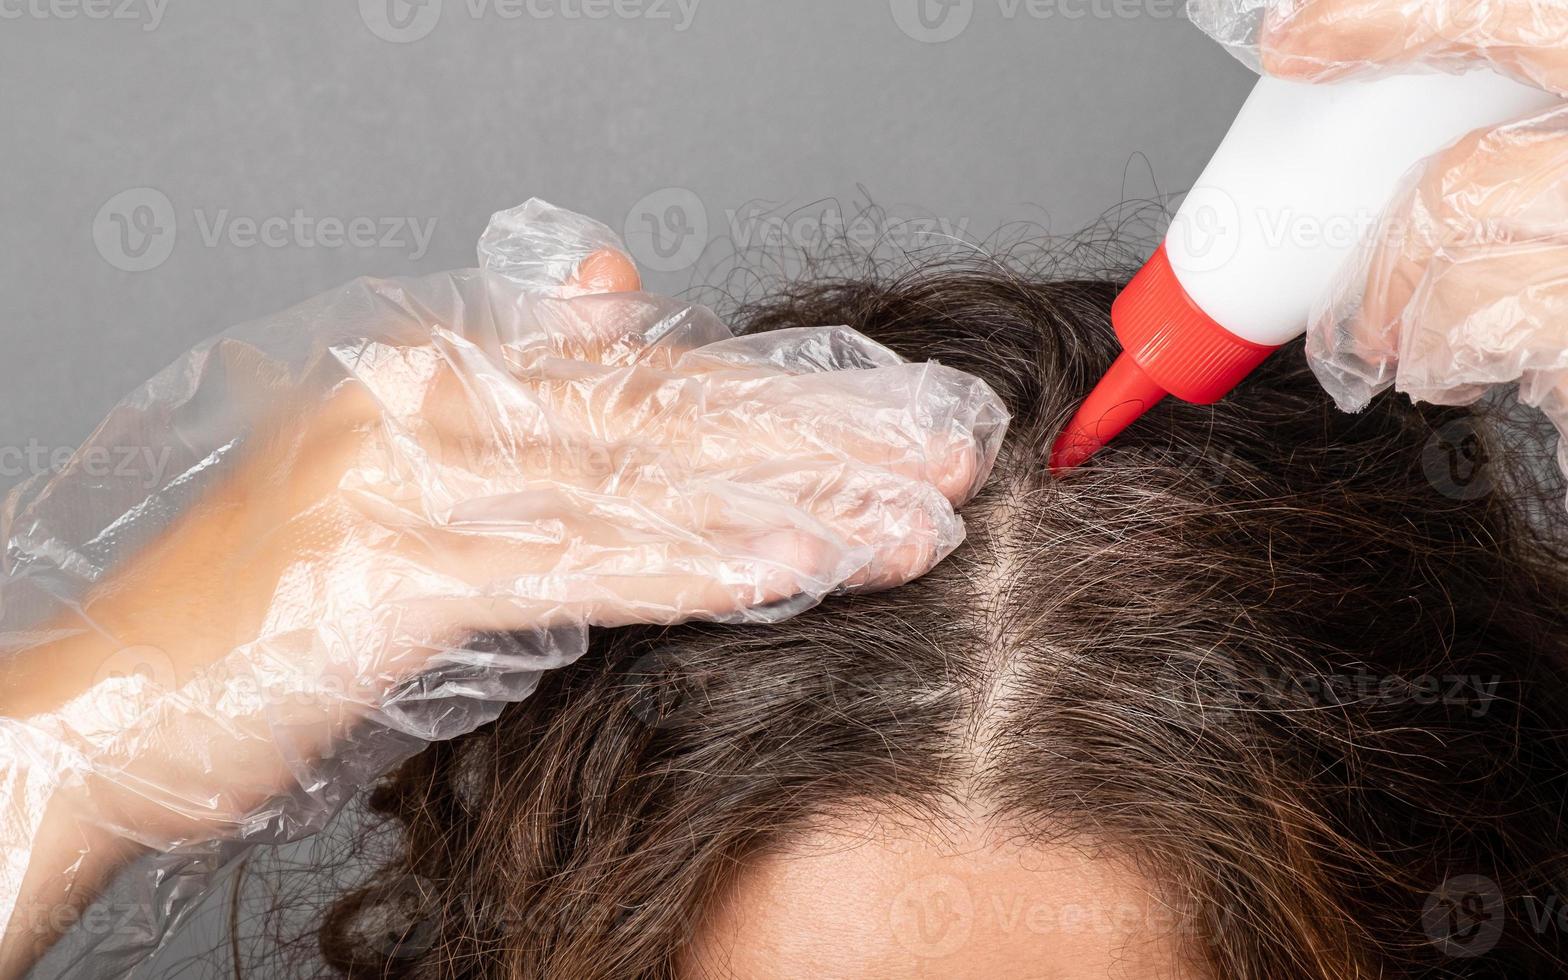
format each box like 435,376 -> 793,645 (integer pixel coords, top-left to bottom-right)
1051,71 -> 1557,474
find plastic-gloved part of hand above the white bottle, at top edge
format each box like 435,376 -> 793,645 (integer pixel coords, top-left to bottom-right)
1187,0 -> 1568,94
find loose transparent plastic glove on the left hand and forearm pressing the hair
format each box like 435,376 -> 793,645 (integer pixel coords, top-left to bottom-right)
0,202 -> 1007,975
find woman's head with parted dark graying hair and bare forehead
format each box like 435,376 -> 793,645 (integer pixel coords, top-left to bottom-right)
321,260 -> 1568,980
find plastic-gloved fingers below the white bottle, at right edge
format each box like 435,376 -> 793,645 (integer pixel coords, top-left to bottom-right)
1308,110 -> 1568,409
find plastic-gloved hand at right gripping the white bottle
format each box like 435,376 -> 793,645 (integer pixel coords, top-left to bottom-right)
1189,0 -> 1568,482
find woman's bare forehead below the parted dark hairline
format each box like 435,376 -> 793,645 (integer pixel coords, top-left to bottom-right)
681,817 -> 1203,980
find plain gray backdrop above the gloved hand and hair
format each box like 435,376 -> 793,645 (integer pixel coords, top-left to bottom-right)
0,0 -> 1251,975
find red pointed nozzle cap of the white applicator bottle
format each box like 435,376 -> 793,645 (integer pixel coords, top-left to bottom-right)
1051,245 -> 1279,475
